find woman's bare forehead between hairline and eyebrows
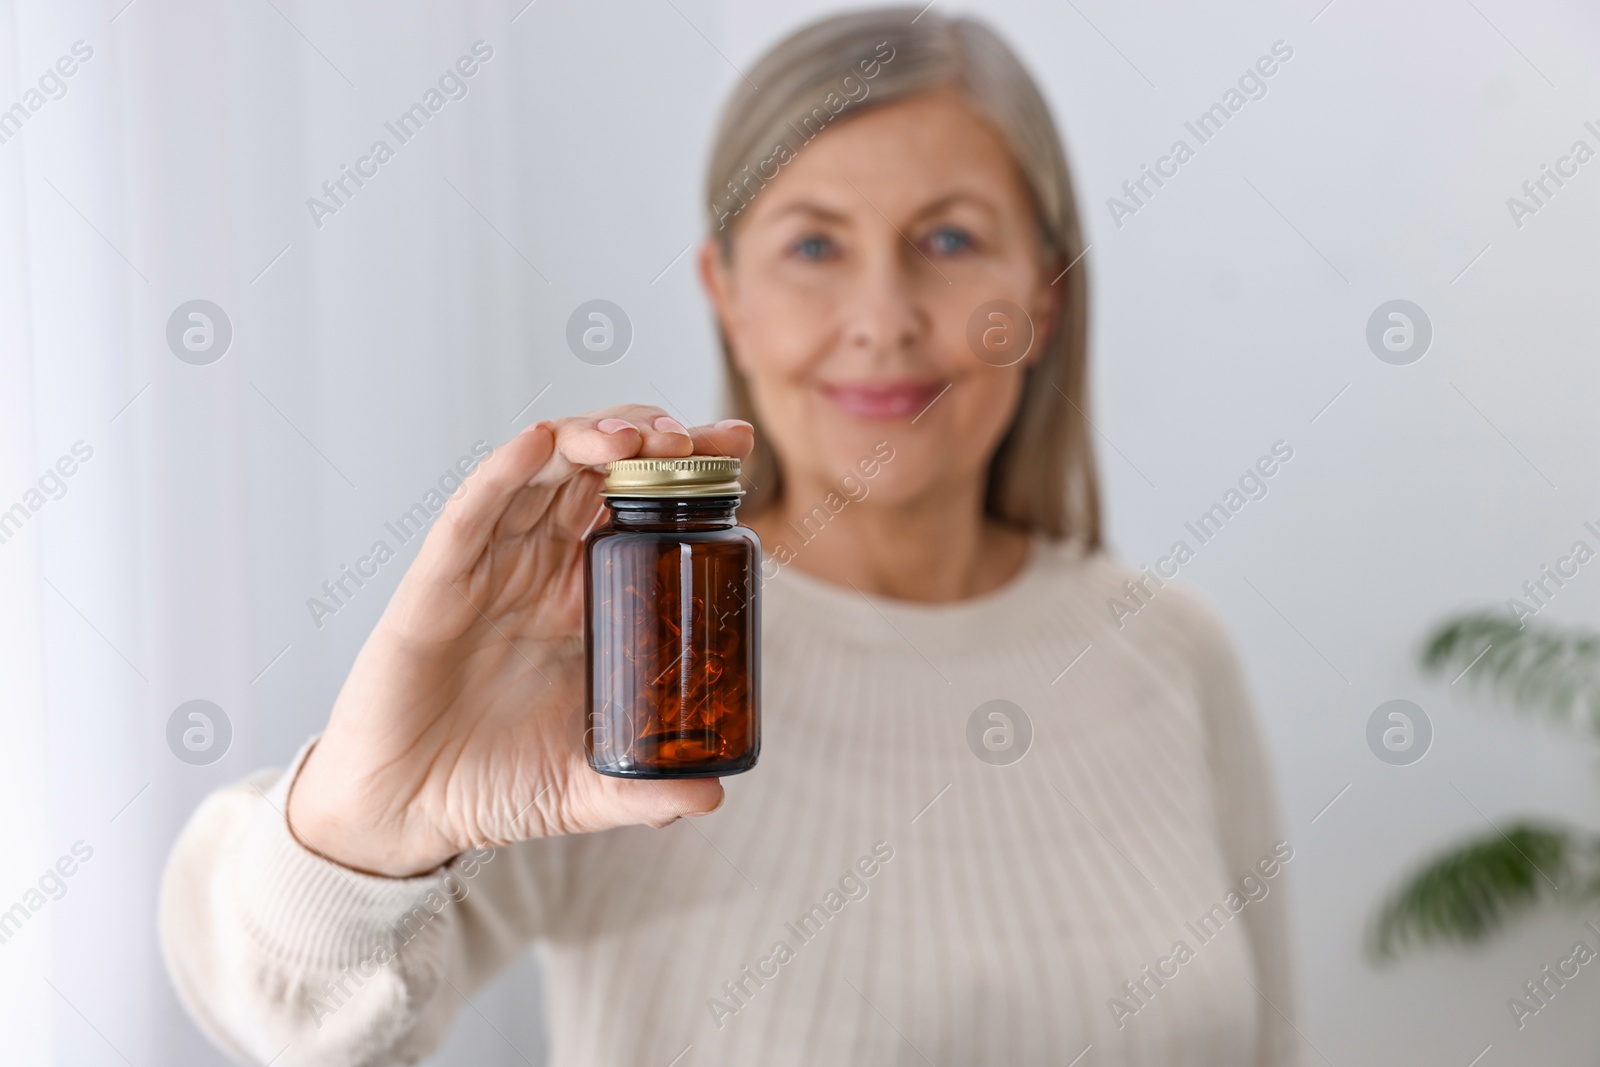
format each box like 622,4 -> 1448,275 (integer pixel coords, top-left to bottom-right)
752,90 -> 1029,221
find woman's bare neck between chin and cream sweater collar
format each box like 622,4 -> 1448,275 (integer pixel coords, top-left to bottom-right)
746,470 -> 1027,603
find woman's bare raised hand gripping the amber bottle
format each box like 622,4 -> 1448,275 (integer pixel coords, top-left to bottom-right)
288,405 -> 754,877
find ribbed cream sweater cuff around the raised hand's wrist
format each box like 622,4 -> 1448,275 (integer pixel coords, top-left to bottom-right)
230,737 -> 448,969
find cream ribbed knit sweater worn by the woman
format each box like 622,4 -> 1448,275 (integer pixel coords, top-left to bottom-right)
162,542 -> 1296,1067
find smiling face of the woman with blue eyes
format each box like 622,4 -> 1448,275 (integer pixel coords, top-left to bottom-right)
701,90 -> 1059,507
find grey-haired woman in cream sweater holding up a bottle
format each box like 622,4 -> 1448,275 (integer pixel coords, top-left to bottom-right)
162,8 -> 1293,1067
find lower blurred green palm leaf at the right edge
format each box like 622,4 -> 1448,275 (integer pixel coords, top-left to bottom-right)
1370,822 -> 1600,960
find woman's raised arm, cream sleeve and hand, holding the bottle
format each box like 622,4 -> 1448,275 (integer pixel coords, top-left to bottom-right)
162,405 -> 754,1067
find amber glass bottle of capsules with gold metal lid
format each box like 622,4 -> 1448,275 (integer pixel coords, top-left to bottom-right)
584,456 -> 762,777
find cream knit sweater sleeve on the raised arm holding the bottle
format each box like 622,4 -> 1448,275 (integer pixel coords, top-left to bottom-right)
158,742 -> 566,1067
